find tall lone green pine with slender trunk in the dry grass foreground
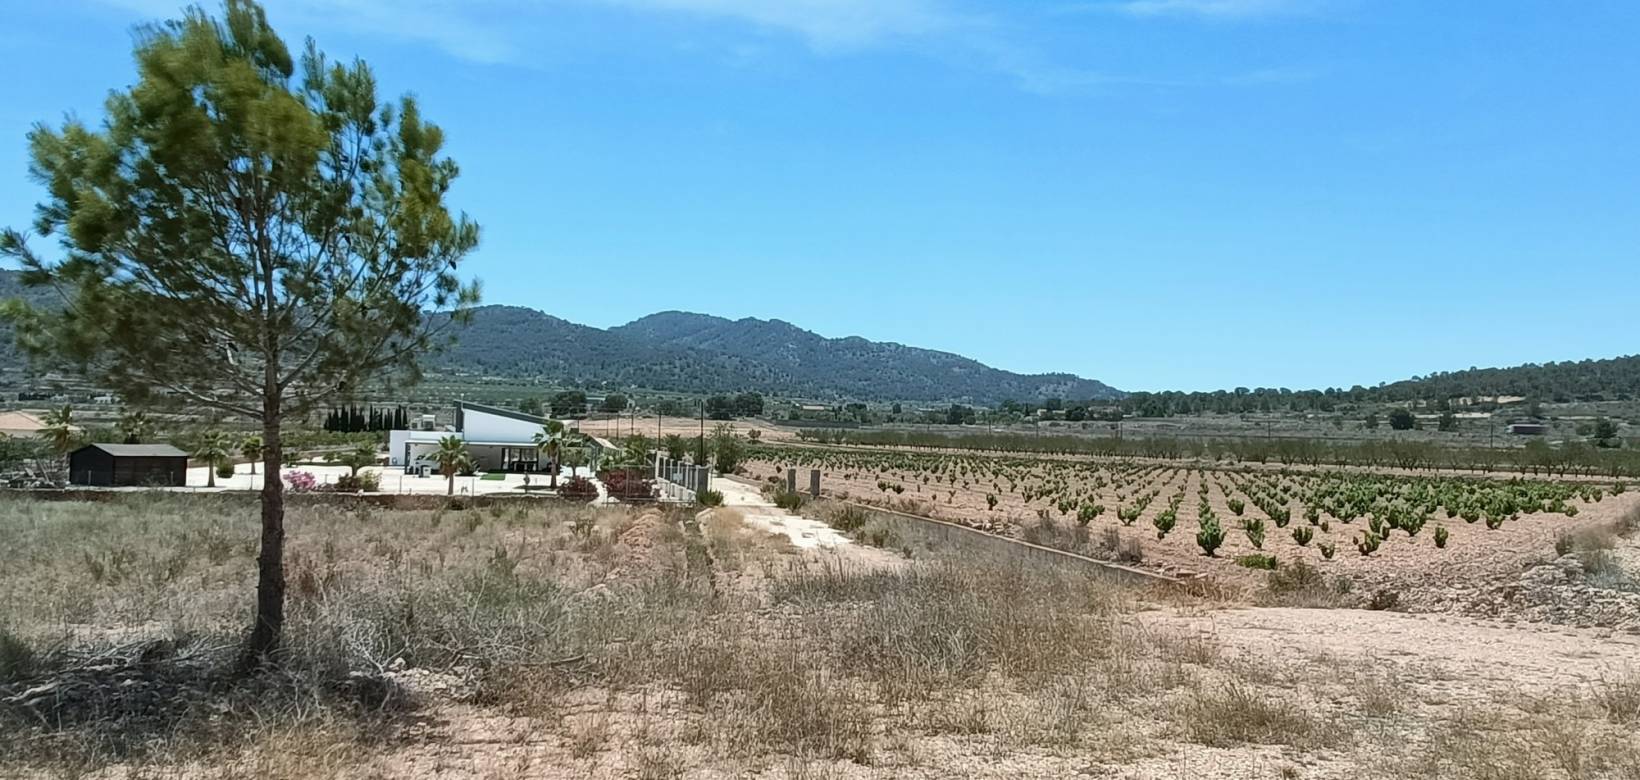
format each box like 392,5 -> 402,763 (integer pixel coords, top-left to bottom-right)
0,0 -> 479,669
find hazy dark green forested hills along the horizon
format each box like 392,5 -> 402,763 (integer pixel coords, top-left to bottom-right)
0,270 -> 1640,405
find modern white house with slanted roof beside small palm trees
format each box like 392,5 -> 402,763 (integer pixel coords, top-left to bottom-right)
387,401 -> 548,474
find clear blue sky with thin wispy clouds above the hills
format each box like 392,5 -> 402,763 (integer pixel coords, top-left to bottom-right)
0,0 -> 1640,390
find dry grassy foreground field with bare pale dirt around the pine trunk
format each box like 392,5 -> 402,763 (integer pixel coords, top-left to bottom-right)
0,493 -> 1640,780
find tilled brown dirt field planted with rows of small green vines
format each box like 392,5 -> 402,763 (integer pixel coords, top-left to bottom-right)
745,456 -> 1640,588
